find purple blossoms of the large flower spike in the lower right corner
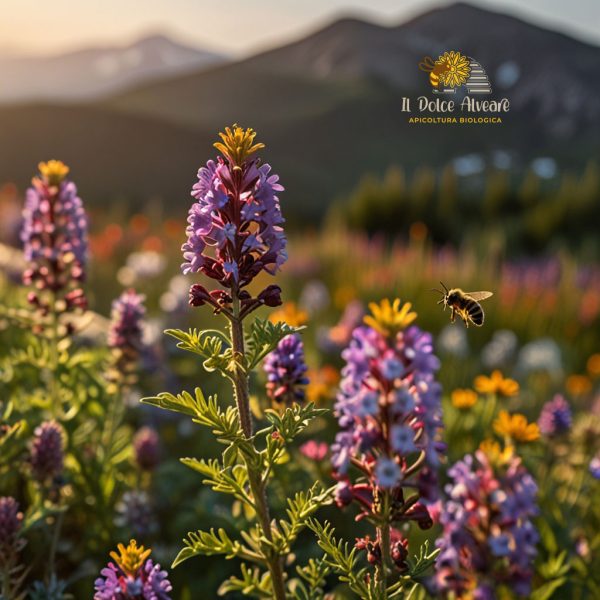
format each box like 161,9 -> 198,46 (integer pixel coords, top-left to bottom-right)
434,450 -> 539,599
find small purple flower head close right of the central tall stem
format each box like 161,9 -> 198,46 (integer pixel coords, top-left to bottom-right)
264,333 -> 308,406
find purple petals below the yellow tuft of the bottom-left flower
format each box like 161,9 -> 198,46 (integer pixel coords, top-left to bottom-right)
94,558 -> 173,600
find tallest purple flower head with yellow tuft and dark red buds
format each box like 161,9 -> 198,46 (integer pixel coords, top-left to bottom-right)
182,125 -> 287,311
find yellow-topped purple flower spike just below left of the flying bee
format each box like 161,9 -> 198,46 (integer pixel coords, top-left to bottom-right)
331,300 -> 443,572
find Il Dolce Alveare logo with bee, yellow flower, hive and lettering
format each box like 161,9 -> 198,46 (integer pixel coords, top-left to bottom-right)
400,50 -> 510,125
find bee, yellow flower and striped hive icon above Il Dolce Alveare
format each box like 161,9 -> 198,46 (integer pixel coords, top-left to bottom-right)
419,50 -> 492,94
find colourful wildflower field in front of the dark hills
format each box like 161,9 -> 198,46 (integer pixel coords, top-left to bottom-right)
0,126 -> 600,600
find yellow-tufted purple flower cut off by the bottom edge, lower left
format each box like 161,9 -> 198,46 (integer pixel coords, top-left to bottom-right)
94,540 -> 173,600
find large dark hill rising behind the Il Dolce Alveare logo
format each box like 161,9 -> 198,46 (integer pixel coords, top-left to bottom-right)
0,3 -> 600,220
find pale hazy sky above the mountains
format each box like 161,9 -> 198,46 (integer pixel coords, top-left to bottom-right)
0,0 -> 600,55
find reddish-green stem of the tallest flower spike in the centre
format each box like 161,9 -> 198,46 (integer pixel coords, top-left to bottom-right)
231,290 -> 286,600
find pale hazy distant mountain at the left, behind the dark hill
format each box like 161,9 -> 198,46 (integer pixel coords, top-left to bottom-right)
0,35 -> 226,102
